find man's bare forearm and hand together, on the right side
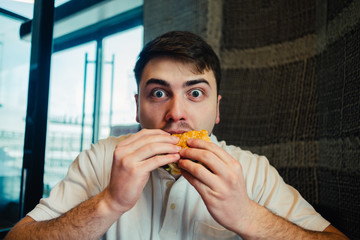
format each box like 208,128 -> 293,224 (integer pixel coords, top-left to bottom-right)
178,139 -> 348,239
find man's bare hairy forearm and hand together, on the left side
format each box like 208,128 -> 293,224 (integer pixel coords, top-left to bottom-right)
6,129 -> 180,239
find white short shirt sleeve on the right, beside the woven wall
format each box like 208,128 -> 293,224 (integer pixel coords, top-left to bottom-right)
224,143 -> 330,231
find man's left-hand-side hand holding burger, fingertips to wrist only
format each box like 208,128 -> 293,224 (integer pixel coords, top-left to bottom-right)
105,129 -> 181,213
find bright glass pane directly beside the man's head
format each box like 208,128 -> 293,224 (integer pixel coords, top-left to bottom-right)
99,26 -> 143,139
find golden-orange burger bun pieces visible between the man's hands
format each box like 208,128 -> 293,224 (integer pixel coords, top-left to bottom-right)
167,130 -> 211,174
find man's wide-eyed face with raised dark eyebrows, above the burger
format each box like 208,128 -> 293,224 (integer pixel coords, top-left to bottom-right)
135,58 -> 221,134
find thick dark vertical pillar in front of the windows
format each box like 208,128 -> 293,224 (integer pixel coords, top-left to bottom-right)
20,0 -> 54,216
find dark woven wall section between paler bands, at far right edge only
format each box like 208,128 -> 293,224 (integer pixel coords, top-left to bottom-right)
317,23 -> 360,137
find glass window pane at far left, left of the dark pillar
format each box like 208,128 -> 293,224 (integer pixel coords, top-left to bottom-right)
0,15 -> 31,229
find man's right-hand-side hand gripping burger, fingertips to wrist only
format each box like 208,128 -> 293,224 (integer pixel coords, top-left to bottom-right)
178,139 -> 253,232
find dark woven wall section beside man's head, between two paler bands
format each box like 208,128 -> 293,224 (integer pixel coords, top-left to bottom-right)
216,59 -> 317,146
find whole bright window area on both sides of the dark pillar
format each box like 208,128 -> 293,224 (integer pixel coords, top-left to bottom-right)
0,0 -> 143,234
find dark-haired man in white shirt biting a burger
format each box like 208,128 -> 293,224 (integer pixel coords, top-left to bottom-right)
8,32 -> 346,239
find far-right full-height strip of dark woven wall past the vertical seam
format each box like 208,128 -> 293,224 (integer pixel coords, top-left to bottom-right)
317,0 -> 360,239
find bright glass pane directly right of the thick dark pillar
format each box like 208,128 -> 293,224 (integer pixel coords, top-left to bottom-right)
44,42 -> 96,196
